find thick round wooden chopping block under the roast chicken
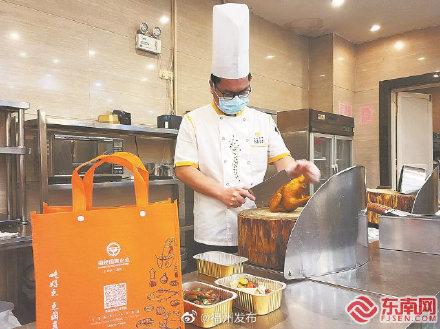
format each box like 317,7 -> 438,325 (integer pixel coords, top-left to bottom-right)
238,208 -> 303,270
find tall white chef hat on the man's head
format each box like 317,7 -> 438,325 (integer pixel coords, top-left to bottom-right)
211,3 -> 249,79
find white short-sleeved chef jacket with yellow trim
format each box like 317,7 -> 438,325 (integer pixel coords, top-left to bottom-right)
174,103 -> 290,246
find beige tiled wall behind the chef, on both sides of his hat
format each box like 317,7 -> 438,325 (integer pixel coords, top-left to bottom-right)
0,0 -> 308,124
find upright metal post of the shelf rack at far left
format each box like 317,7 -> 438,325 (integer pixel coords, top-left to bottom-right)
18,109 -> 28,224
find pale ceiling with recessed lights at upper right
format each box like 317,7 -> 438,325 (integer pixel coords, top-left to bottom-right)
236,0 -> 440,43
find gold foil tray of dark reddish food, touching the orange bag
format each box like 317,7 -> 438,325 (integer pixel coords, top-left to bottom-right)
182,281 -> 237,328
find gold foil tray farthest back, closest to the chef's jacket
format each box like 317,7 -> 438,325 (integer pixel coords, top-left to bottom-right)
194,251 -> 248,278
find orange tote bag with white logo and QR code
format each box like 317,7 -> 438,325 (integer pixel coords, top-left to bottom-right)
32,152 -> 184,329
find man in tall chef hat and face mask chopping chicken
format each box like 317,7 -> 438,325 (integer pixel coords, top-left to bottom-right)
175,3 -> 320,253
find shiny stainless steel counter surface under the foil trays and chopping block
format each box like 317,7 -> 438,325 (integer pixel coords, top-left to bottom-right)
14,242 -> 440,329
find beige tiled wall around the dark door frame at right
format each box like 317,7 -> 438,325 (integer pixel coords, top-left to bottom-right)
354,27 -> 440,187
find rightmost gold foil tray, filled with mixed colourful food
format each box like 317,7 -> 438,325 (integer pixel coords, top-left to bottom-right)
215,273 -> 286,315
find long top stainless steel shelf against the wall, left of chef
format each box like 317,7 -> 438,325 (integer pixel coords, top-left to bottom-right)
26,118 -> 178,138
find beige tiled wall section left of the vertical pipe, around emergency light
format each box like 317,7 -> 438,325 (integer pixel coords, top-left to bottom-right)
0,0 -> 175,123
